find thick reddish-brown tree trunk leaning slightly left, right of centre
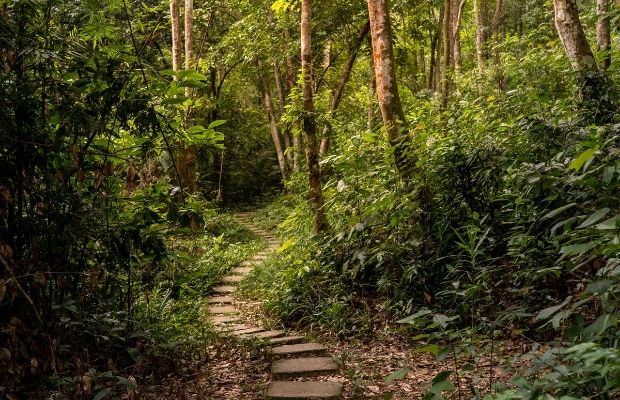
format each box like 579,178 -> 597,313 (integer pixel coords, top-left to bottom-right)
368,0 -> 412,177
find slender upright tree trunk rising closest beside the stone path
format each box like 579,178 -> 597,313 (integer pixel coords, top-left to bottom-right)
301,0 -> 328,233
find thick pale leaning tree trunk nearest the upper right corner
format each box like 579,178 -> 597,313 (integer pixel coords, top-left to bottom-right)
553,0 -> 596,71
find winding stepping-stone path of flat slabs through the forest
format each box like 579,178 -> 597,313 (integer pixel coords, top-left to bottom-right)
208,213 -> 343,400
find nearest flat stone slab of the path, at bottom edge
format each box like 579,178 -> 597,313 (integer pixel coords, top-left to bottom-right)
265,381 -> 342,400
